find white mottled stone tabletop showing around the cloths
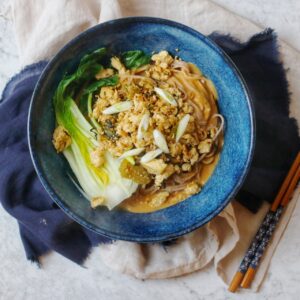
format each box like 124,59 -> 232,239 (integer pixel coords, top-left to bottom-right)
0,0 -> 300,300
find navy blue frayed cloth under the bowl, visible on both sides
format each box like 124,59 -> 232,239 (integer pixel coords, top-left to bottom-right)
0,30 -> 299,264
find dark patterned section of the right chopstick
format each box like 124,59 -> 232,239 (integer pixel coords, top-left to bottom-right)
250,206 -> 283,269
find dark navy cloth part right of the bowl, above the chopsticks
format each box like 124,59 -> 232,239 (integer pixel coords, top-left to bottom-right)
212,29 -> 300,212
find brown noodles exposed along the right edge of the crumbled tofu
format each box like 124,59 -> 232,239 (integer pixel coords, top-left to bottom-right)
122,54 -> 224,211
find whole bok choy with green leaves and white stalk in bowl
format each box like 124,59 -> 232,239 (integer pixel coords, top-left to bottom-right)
53,48 -> 138,209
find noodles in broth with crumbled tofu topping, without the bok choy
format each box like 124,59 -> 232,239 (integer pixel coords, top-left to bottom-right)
82,51 -> 224,212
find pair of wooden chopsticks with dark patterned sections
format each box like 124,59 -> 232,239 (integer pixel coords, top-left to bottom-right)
228,152 -> 300,293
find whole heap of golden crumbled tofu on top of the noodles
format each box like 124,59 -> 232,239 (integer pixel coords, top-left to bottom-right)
81,51 -> 219,186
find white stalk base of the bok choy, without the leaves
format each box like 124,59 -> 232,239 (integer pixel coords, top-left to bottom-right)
56,100 -> 138,209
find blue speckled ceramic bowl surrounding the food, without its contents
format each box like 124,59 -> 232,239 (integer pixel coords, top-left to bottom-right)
28,17 -> 254,242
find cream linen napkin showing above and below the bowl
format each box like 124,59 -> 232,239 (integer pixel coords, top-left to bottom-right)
7,0 -> 300,290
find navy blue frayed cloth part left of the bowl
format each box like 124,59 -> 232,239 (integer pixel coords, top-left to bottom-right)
0,62 -> 110,263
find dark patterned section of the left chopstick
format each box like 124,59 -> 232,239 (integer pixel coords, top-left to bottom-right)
239,211 -> 274,273
